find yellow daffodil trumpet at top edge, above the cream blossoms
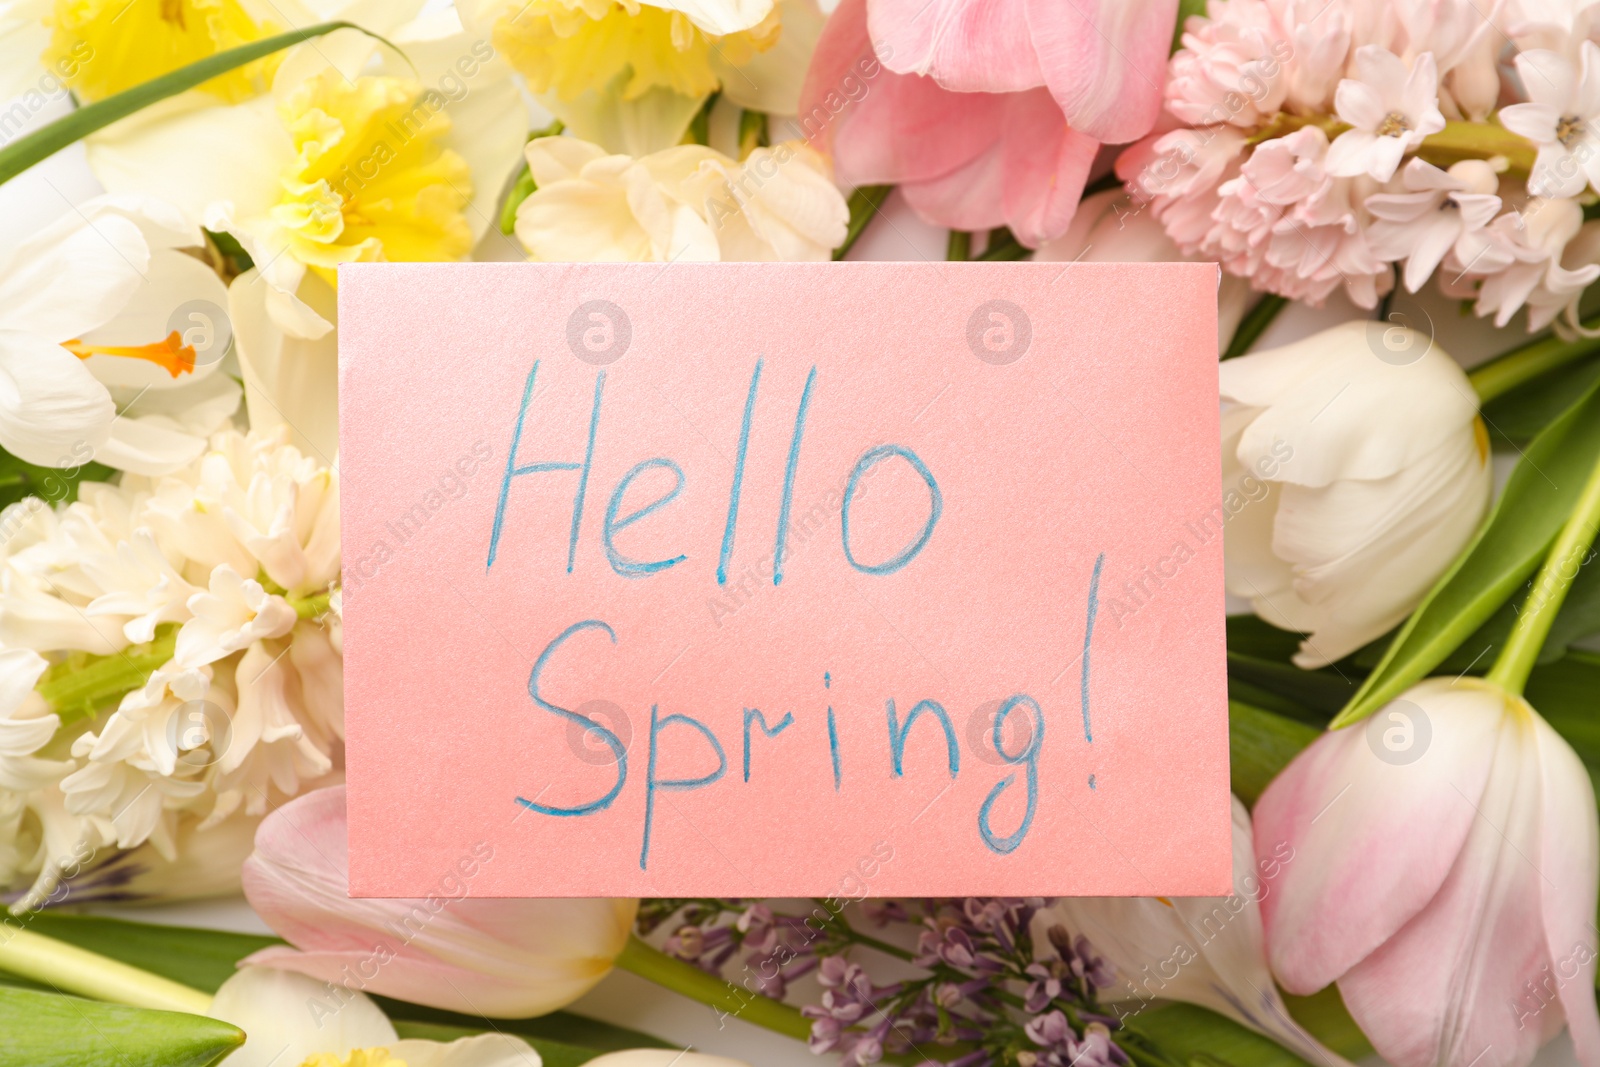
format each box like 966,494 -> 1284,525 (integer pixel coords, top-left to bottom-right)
494,0 -> 779,99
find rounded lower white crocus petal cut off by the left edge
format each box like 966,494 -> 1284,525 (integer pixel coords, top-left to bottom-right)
0,331 -> 117,467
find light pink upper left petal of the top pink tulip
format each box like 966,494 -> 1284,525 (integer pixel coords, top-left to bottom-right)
867,0 -> 1045,93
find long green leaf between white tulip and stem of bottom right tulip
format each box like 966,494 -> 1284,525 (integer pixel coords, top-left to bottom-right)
1333,371 -> 1600,728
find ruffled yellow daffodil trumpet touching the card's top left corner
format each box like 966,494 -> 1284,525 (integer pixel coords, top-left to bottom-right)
270,70 -> 472,285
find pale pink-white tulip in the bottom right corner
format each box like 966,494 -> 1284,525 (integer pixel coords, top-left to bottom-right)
1254,678 -> 1600,1067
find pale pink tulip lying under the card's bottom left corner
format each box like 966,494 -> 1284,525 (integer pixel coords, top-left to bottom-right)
243,785 -> 638,1017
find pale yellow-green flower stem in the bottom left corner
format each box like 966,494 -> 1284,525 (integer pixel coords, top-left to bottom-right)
0,923 -> 211,1016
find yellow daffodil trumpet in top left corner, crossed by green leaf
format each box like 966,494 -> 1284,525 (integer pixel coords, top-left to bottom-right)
43,0 -> 278,102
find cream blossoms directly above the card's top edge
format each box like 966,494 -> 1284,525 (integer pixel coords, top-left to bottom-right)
517,138 -> 850,262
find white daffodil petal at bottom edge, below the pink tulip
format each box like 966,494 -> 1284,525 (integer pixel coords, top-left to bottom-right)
208,966 -> 397,1067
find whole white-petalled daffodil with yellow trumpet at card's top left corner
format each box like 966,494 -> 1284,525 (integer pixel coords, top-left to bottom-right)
86,8 -> 526,462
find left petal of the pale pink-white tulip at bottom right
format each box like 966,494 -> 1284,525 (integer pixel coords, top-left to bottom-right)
1254,678 -> 1502,993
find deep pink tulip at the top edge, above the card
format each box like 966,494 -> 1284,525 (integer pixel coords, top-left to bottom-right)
798,0 -> 1176,248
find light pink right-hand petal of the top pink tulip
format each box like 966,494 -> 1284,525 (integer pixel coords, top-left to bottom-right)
1026,0 -> 1178,144
